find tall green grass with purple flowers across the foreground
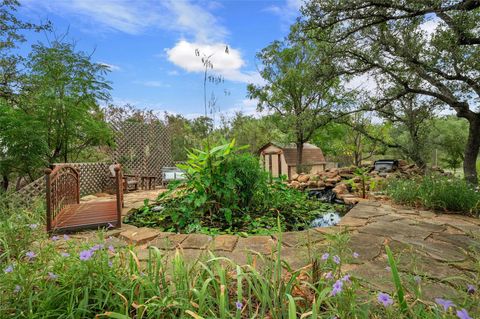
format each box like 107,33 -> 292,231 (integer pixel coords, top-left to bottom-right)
0,199 -> 479,319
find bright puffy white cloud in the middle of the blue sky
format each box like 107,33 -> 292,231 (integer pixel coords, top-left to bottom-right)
165,40 -> 261,83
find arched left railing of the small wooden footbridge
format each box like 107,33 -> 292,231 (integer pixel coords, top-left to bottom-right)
45,165 -> 80,231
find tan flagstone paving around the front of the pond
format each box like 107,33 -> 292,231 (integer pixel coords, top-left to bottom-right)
75,190 -> 480,299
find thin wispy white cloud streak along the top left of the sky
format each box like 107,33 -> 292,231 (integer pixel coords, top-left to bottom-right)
22,0 -> 228,42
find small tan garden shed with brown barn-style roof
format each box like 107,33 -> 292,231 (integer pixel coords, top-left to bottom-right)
258,142 -> 327,180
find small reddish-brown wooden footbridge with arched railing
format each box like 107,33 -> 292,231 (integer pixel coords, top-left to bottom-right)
45,165 -> 123,232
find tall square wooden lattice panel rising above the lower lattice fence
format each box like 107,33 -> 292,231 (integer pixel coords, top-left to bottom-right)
112,122 -> 173,183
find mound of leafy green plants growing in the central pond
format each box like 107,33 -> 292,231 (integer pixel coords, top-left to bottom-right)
124,141 -> 340,233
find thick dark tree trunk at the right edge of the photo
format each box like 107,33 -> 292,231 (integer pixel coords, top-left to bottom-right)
463,114 -> 480,185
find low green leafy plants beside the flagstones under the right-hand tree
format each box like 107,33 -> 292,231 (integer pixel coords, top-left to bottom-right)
386,174 -> 480,214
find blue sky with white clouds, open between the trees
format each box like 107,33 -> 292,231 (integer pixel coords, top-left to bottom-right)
19,0 -> 301,117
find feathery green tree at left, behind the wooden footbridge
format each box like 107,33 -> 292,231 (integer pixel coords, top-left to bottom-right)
0,41 -> 112,189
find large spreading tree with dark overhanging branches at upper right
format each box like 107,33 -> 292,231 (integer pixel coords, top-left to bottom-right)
303,0 -> 480,183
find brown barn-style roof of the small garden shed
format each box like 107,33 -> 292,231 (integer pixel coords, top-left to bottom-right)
258,142 -> 326,166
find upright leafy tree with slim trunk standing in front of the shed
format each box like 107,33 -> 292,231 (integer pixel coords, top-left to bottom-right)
248,25 -> 341,168
